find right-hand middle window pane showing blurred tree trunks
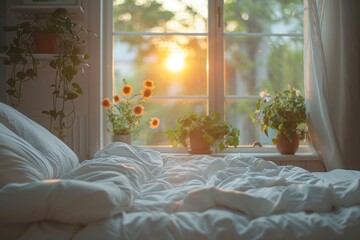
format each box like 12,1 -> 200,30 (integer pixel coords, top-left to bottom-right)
225,37 -> 304,96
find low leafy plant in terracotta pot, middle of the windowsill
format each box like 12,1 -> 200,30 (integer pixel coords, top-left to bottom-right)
166,113 -> 240,154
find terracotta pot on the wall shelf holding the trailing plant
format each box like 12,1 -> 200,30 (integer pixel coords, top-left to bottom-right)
32,32 -> 57,53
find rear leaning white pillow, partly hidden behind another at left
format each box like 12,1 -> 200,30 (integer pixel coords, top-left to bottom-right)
0,102 -> 79,178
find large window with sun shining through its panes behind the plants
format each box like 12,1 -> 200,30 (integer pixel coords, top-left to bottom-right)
112,0 -> 303,150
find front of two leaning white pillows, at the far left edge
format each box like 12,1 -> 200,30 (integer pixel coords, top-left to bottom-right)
0,123 -> 54,188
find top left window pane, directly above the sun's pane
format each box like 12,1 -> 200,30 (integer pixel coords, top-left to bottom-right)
114,0 -> 208,33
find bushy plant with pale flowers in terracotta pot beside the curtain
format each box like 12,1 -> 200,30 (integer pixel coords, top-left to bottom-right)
253,87 -> 306,154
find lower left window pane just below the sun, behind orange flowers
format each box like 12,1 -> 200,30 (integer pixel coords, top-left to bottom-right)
133,99 -> 207,145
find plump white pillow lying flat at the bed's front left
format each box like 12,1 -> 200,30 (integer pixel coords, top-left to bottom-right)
0,180 -> 127,226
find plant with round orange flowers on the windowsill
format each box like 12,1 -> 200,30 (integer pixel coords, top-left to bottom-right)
101,79 -> 160,136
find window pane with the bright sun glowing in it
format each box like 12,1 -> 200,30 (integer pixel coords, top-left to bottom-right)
114,36 -> 207,96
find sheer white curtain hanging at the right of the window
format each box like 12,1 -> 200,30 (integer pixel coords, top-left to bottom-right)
304,0 -> 360,170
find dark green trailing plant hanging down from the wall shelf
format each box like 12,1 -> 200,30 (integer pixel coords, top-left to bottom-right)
2,8 -> 93,138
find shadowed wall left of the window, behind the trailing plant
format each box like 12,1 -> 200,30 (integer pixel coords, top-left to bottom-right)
0,0 -> 102,160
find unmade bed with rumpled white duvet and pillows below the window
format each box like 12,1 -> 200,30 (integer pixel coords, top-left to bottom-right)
0,103 -> 360,240
